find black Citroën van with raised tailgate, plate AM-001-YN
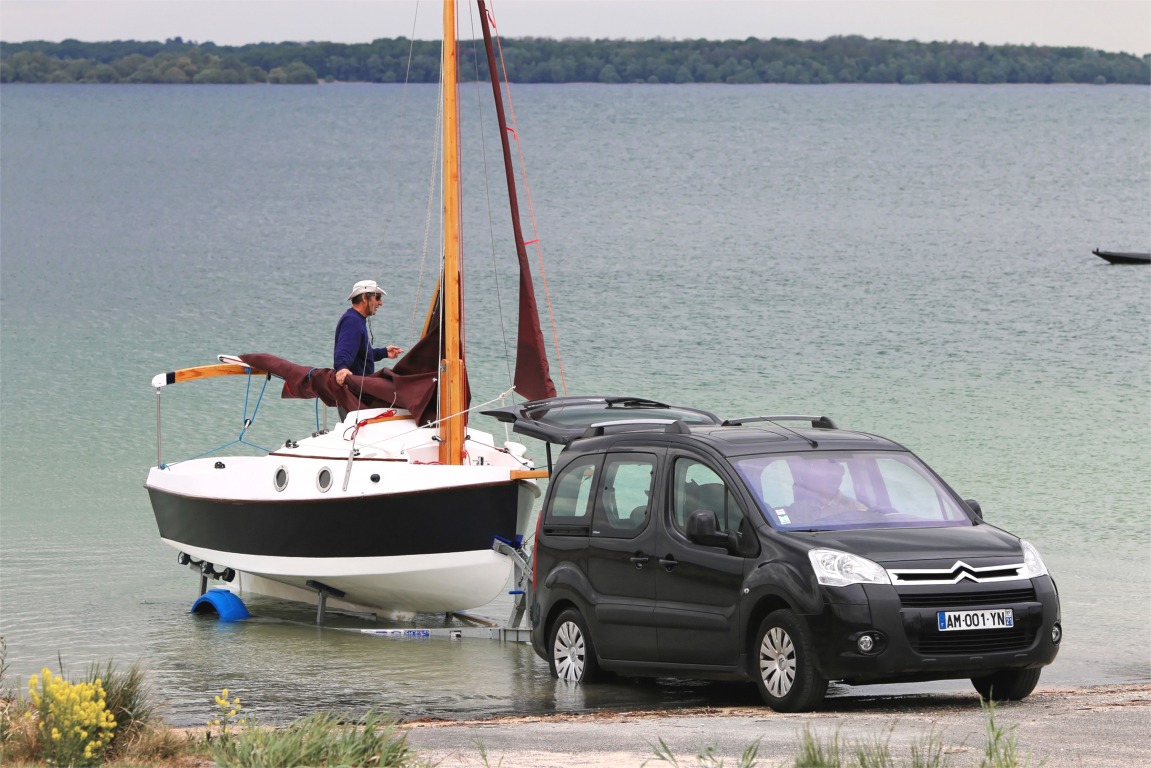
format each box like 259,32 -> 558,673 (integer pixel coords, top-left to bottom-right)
488,397 -> 1062,712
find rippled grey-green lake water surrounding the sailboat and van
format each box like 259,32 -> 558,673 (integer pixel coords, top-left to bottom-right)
0,85 -> 1151,724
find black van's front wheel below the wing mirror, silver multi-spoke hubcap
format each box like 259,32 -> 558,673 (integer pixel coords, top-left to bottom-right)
752,609 -> 828,712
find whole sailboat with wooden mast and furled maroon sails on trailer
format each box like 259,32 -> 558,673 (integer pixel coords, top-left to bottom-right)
145,0 -> 556,615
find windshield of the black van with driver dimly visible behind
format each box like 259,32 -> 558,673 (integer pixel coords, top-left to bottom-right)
733,451 -> 973,531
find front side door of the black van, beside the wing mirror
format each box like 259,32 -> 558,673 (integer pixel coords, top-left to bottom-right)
656,455 -> 759,667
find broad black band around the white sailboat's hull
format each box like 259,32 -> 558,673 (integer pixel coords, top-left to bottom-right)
148,482 -> 519,557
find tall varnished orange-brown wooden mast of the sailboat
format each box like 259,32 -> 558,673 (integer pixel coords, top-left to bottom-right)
439,0 -> 467,464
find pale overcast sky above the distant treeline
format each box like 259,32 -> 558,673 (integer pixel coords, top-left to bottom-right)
0,0 -> 1151,55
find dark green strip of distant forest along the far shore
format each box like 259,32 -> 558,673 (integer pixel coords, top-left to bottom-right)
0,36 -> 1151,85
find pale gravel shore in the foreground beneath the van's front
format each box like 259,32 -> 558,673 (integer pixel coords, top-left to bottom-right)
404,682 -> 1151,768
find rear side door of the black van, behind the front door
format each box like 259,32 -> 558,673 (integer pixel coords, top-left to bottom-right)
587,453 -> 657,660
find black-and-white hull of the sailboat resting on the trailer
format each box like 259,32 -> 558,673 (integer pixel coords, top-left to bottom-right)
146,412 -> 539,614
